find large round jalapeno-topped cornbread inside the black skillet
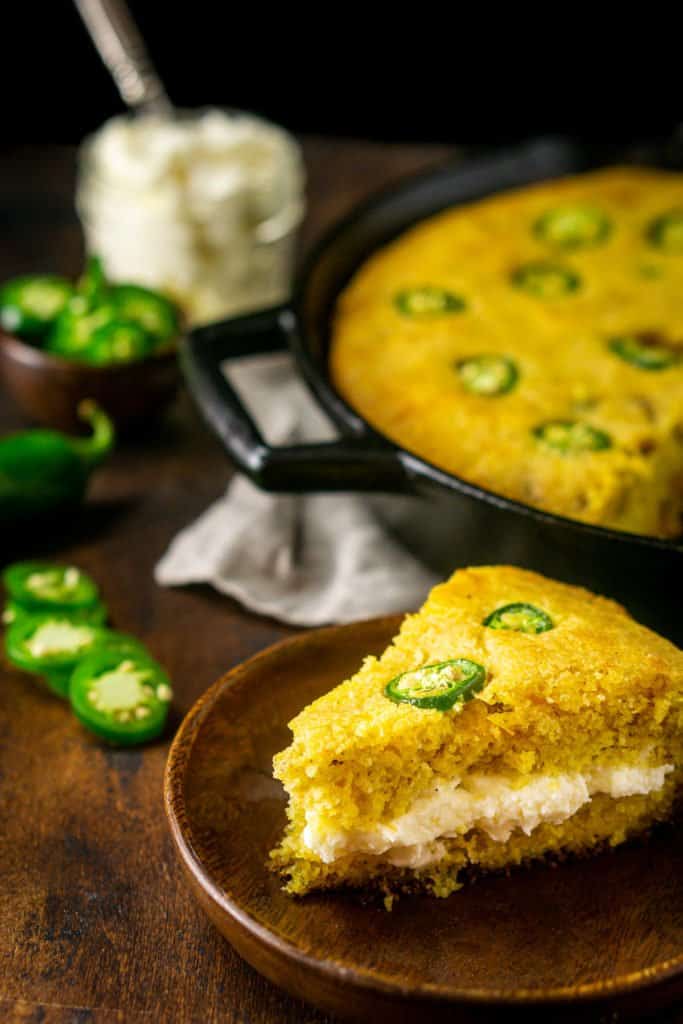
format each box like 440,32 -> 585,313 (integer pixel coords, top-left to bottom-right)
331,168 -> 683,537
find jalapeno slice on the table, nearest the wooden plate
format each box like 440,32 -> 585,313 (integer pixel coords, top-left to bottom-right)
70,650 -> 173,746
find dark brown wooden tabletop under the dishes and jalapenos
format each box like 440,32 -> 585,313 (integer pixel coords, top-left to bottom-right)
0,140 -> 454,1024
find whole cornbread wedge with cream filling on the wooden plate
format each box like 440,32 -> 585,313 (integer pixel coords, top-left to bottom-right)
271,567 -> 683,896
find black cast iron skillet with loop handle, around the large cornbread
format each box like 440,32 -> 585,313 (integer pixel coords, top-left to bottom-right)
181,139 -> 683,644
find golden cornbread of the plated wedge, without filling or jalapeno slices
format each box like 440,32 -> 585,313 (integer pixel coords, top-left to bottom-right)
272,566 -> 683,895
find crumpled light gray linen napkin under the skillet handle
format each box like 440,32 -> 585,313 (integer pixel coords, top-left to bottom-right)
155,353 -> 436,626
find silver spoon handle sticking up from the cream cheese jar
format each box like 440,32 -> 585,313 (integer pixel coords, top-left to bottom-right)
74,0 -> 173,115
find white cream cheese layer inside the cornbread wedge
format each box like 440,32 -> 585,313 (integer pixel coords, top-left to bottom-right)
303,764 -> 674,867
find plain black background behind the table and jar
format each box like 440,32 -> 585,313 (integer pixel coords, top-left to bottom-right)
0,0 -> 683,143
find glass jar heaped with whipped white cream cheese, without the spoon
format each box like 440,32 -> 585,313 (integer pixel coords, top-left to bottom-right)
76,110 -> 304,324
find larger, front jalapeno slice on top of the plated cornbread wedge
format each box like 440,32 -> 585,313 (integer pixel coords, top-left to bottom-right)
384,657 -> 486,711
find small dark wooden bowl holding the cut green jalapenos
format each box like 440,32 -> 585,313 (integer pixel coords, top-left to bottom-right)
0,331 -> 180,432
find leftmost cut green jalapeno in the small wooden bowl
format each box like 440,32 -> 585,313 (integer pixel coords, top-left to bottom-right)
0,273 -> 74,338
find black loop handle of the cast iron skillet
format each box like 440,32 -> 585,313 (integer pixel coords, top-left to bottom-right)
180,306 -> 412,494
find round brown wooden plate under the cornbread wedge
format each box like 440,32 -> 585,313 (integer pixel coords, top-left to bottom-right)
165,616 -> 683,1024
